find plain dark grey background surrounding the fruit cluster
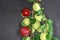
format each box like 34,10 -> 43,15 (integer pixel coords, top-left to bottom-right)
0,0 -> 60,40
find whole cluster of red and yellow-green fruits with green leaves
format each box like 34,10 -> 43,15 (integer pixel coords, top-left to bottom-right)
19,1 -> 58,40
